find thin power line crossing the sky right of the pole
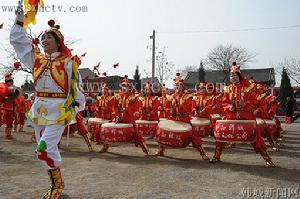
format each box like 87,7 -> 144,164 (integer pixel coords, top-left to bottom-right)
158,24 -> 300,34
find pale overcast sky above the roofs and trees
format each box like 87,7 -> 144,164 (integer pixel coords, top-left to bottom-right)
0,0 -> 300,84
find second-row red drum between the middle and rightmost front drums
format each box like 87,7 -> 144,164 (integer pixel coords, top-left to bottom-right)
191,118 -> 211,137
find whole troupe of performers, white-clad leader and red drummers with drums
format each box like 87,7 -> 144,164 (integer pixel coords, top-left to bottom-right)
0,3 -> 281,199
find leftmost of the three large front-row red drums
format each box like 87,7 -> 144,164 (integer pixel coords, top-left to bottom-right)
100,123 -> 135,143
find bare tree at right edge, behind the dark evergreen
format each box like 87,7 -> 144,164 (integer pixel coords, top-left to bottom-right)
274,58 -> 300,84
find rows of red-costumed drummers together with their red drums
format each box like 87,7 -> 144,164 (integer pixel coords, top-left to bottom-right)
77,62 -> 282,167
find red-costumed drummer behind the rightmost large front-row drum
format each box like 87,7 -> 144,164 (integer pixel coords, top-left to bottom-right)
210,62 -> 275,167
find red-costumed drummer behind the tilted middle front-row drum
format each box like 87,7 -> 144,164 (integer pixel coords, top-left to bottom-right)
155,73 -> 209,160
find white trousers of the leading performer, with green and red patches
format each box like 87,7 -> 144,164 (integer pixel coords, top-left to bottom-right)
33,125 -> 65,170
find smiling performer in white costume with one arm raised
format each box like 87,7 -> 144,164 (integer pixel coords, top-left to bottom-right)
10,3 -> 85,199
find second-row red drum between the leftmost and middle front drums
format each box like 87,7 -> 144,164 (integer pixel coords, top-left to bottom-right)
135,120 -> 158,138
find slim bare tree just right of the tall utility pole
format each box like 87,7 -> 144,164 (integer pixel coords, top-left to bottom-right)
155,47 -> 174,84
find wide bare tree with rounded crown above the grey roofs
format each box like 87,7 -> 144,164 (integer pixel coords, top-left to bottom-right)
206,45 -> 256,81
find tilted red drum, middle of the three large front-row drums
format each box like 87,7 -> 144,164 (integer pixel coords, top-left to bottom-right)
155,120 -> 193,148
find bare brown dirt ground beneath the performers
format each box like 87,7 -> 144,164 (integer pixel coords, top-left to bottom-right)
0,123 -> 300,199
